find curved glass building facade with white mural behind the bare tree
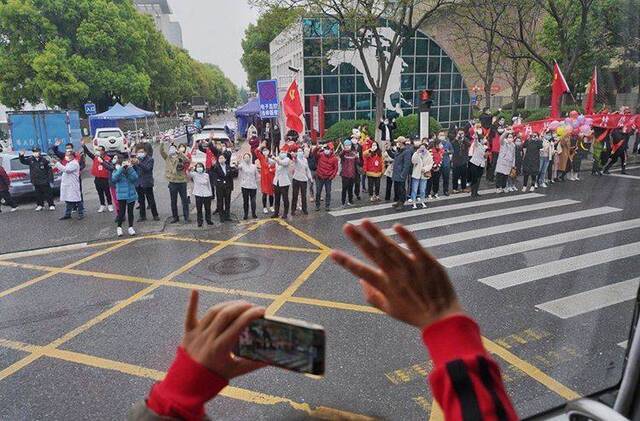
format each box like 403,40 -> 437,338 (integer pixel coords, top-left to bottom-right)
270,18 -> 471,127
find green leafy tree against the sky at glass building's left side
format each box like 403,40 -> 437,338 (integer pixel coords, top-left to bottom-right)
240,5 -> 301,90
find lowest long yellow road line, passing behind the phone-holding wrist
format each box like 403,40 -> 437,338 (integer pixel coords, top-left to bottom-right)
0,339 -> 374,420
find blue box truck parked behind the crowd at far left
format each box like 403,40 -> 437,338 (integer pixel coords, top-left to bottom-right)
7,110 -> 82,153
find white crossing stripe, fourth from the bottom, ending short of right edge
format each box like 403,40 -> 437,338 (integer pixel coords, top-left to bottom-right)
420,206 -> 622,247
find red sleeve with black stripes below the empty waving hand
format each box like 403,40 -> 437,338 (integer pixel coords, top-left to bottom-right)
422,315 -> 518,421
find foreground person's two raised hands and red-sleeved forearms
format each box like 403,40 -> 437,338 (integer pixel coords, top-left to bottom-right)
129,221 -> 518,421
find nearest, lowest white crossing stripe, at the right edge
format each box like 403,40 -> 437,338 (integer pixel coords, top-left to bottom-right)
536,278 -> 640,319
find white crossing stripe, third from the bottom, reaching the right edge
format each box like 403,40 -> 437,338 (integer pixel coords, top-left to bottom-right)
439,216 -> 640,267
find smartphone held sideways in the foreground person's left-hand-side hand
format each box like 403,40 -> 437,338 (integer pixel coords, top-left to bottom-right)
234,316 -> 325,375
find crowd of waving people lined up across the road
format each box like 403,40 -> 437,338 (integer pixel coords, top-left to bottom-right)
0,112 -> 637,236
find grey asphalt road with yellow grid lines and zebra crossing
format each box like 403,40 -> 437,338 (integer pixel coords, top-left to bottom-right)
0,159 -> 640,420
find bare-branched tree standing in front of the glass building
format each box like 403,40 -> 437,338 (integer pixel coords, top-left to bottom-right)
251,0 -> 459,139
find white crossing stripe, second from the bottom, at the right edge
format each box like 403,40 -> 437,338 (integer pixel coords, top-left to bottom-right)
478,242 -> 640,289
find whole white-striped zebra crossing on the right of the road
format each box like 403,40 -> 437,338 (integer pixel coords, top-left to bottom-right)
331,190 -> 640,344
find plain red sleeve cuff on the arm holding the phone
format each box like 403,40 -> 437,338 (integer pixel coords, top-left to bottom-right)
147,347 -> 228,421
